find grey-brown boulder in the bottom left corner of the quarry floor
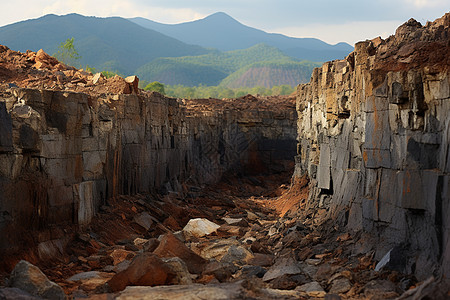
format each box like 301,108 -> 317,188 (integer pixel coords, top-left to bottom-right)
10,260 -> 66,299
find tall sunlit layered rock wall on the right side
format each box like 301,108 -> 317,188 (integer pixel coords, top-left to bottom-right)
296,14 -> 450,280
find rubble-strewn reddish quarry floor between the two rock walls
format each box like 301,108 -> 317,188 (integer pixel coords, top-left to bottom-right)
0,168 -> 442,299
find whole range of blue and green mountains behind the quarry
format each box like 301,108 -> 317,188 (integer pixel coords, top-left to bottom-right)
0,13 -> 353,87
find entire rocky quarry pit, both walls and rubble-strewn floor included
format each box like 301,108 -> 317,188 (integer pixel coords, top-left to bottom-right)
0,14 -> 450,299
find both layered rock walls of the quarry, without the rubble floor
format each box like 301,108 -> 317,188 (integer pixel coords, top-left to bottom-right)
0,14 -> 450,286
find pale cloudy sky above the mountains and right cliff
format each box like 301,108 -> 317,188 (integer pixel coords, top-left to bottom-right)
0,0 -> 450,45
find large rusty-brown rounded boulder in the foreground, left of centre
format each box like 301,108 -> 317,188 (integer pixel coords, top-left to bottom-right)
108,253 -> 175,292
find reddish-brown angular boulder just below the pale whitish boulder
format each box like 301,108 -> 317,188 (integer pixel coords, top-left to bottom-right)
153,233 -> 207,274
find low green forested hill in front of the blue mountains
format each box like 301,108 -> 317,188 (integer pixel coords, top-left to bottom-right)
137,44 -> 319,88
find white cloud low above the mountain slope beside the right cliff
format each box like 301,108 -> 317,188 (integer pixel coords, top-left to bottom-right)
272,21 -> 404,45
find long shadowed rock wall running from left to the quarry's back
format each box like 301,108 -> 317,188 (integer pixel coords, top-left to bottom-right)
0,89 -> 297,268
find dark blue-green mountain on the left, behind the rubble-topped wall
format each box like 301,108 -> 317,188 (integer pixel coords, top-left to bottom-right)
0,14 -> 209,75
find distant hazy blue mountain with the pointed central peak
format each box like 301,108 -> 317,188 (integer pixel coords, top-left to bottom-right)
129,12 -> 353,61
